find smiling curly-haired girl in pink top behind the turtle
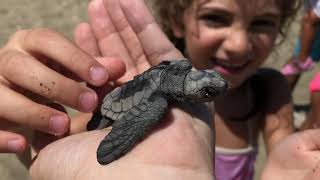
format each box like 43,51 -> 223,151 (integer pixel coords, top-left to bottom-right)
152,0 -> 299,180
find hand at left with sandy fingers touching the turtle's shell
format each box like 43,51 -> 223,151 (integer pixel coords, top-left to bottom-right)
0,28 -> 124,153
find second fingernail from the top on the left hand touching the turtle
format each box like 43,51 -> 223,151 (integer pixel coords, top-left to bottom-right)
79,92 -> 98,112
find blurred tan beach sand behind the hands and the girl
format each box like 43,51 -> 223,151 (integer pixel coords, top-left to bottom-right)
0,0 -> 320,180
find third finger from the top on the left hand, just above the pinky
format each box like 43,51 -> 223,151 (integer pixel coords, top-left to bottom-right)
0,85 -> 70,135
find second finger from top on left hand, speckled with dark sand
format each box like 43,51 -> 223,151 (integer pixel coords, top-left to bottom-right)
0,51 -> 101,112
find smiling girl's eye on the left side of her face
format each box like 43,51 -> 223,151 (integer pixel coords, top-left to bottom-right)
199,14 -> 231,27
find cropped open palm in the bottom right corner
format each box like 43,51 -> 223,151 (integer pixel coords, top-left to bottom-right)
261,129 -> 320,180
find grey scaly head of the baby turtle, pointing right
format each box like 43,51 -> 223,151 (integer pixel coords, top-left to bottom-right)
184,70 -> 228,102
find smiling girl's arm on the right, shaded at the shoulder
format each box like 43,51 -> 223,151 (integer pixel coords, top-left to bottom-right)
262,69 -> 294,153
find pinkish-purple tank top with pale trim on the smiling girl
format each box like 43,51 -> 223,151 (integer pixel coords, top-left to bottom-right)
215,146 -> 257,180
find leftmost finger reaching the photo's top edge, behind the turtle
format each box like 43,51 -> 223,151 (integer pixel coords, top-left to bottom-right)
88,0 -> 138,81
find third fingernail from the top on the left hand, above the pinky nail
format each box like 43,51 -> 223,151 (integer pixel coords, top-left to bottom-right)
50,115 -> 68,135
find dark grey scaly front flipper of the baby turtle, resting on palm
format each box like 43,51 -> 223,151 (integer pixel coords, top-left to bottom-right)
97,96 -> 168,164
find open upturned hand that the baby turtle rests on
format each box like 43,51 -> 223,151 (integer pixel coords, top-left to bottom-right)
30,0 -> 213,180
